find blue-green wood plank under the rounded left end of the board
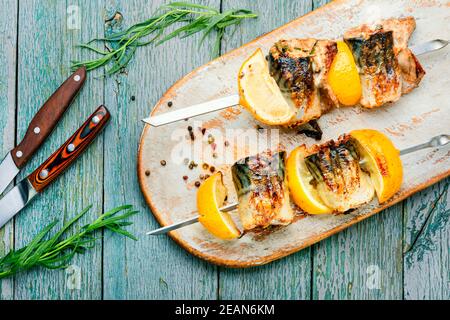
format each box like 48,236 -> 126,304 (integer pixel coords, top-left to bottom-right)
103,0 -> 220,299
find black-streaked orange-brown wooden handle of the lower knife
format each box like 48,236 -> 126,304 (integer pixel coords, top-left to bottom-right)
28,106 -> 111,192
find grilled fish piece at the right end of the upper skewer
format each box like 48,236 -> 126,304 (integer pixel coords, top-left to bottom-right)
344,17 -> 425,108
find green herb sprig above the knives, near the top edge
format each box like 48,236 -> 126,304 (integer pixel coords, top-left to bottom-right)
72,2 -> 258,75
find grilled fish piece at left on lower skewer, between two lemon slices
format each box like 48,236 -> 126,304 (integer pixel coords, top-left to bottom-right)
231,152 -> 294,231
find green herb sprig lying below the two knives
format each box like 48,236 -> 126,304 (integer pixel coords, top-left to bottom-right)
0,205 -> 137,279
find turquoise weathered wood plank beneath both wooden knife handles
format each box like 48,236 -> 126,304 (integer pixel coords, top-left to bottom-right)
15,0 -> 103,299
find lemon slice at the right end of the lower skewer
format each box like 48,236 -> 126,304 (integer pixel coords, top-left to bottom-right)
350,129 -> 403,203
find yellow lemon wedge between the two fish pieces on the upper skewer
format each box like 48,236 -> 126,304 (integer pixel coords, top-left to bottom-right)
328,41 -> 362,106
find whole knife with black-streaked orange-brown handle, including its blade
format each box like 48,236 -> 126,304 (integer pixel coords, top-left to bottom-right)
0,106 -> 111,228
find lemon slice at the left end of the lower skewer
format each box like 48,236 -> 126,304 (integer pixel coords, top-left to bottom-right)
197,172 -> 241,240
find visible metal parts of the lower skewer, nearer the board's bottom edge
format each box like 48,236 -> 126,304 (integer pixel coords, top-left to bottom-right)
147,134 -> 450,236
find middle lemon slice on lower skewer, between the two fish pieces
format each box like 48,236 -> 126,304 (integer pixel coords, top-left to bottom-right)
286,145 -> 333,214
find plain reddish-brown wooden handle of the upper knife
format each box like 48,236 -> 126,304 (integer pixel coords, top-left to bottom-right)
11,67 -> 86,169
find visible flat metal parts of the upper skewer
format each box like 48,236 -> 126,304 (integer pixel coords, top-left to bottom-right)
142,39 -> 448,127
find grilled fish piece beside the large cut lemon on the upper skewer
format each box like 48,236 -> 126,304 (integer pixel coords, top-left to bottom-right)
269,39 -> 338,127
